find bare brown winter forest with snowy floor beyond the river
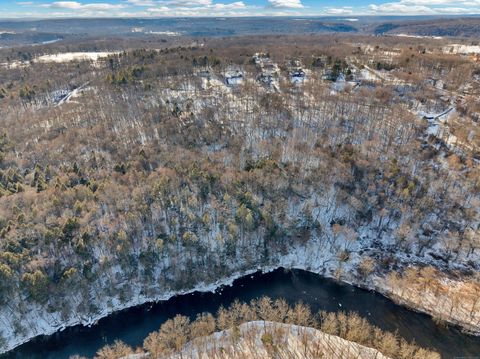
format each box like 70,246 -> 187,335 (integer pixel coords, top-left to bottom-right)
0,35 -> 480,351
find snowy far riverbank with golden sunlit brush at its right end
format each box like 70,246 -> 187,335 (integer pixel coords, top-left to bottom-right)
0,231 -> 480,353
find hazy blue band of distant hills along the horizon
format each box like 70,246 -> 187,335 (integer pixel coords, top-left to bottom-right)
0,16 -> 480,47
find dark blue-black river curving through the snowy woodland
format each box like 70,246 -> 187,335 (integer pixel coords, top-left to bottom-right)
1,269 -> 480,359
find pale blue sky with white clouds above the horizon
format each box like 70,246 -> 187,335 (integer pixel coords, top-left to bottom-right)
0,0 -> 480,20
